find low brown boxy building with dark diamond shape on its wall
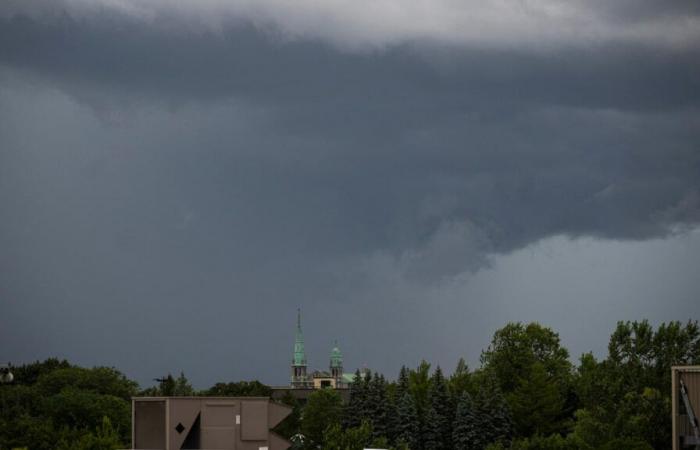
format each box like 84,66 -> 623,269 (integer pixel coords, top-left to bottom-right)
131,397 -> 292,450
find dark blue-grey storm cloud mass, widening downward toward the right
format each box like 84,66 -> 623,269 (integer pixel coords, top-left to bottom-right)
0,7 -> 700,251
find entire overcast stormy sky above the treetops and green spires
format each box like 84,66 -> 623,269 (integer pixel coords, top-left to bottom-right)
0,0 -> 700,387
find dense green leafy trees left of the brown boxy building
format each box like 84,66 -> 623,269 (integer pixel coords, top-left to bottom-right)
0,359 -> 137,450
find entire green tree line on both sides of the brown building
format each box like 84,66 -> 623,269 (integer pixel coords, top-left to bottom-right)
0,321 -> 700,450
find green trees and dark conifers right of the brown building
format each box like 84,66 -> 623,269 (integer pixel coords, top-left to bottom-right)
282,321 -> 700,450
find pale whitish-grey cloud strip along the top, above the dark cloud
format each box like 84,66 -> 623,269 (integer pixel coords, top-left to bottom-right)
5,0 -> 700,50
